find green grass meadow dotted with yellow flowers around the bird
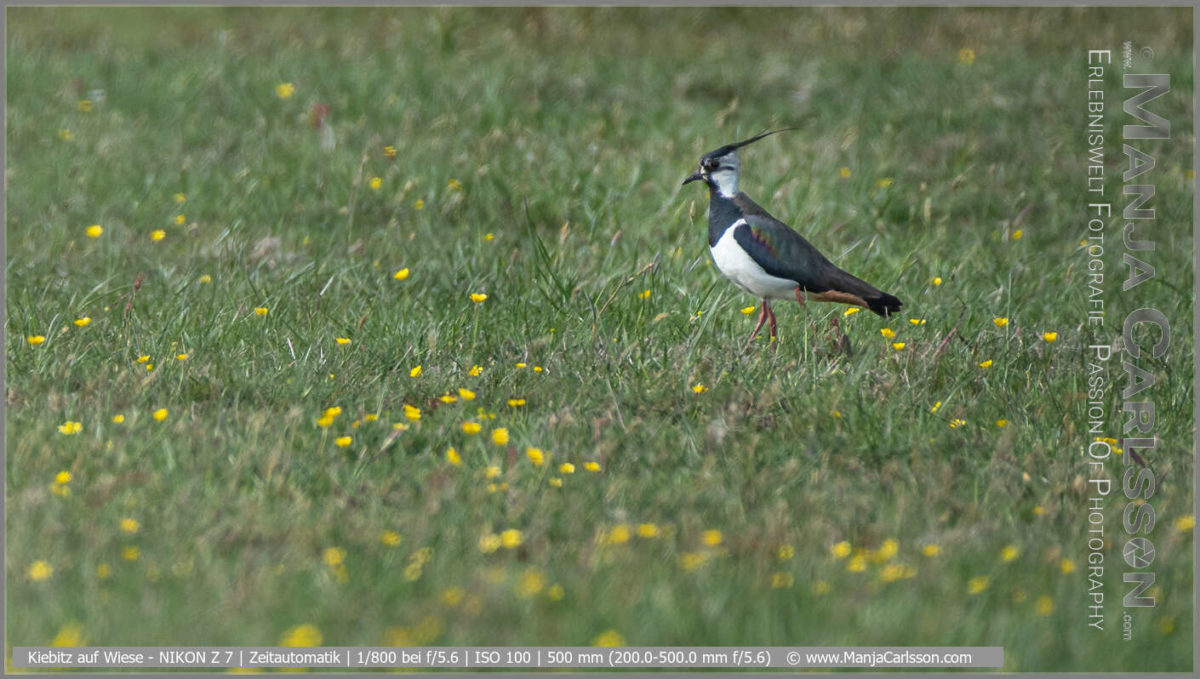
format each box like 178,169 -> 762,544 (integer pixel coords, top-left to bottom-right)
5,8 -> 1194,672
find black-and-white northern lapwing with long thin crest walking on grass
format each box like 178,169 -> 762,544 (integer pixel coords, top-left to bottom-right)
683,130 -> 900,345
